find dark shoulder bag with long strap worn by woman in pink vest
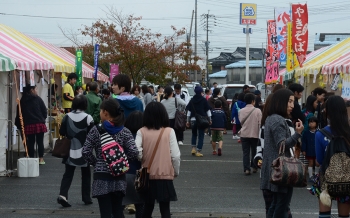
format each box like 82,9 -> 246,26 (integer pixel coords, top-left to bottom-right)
134,128 -> 165,194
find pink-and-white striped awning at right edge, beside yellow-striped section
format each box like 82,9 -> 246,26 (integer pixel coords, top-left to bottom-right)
322,52 -> 350,74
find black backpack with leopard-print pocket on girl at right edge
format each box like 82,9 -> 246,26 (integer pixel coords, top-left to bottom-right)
319,128 -> 350,205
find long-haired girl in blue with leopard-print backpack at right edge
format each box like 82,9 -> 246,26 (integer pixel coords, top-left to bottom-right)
310,96 -> 350,218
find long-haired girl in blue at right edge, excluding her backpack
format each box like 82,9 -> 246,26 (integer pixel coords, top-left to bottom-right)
313,95 -> 350,218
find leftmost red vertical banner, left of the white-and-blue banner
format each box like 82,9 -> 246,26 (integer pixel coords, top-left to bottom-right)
266,20 -> 279,66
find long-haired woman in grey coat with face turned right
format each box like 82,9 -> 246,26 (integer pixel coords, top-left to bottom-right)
260,89 -> 304,218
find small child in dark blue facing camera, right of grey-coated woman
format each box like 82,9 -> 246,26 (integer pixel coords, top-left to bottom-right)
301,117 -> 320,182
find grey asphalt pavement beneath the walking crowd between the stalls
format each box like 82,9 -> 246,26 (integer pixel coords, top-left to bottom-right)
0,130 -> 335,218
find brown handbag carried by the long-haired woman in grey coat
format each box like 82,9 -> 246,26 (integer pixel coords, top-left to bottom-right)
270,141 -> 307,187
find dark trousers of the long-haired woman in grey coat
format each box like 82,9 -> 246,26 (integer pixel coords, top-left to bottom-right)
266,187 -> 293,218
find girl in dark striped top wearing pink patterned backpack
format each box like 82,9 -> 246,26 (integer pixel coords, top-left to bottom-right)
82,99 -> 138,218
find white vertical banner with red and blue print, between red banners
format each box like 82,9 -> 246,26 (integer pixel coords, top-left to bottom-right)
275,8 -> 291,63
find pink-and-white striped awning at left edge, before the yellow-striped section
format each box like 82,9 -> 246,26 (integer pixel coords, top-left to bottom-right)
0,31 -> 54,71
